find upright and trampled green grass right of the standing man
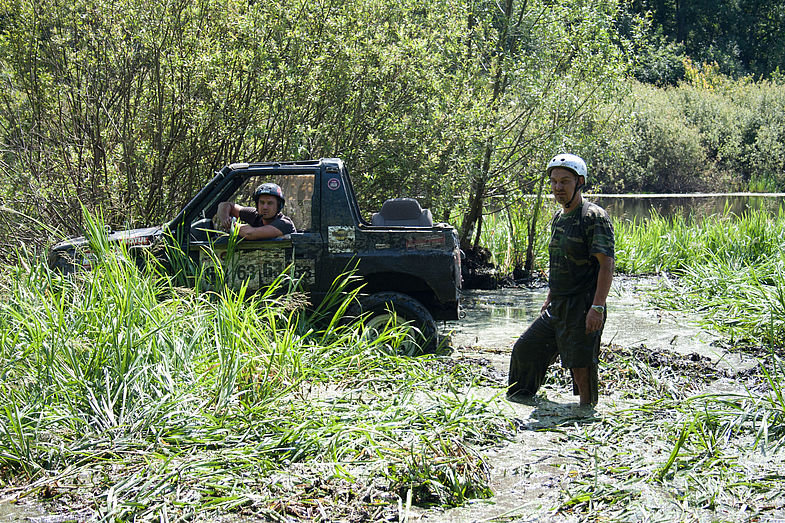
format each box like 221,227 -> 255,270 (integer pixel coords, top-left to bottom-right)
562,208 -> 785,520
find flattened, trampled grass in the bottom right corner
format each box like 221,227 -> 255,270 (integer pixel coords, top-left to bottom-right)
557,348 -> 785,521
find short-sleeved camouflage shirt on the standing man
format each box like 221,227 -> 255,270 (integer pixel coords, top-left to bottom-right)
548,200 -> 615,296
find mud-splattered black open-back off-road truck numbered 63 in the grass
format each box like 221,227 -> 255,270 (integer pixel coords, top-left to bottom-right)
49,158 -> 461,350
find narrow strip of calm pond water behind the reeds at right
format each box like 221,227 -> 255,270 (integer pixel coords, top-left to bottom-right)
587,193 -> 785,220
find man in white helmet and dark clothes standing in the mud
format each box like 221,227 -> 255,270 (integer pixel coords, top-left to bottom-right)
507,154 -> 614,406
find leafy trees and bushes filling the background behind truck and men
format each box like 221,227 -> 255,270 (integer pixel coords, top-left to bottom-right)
0,0 -> 785,260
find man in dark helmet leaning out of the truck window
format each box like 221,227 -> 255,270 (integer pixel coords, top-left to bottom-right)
213,183 -> 296,240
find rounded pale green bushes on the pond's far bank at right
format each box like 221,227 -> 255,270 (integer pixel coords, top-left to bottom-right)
591,77 -> 785,192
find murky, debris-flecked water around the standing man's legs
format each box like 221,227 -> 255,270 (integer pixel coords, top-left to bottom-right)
420,278 -> 755,523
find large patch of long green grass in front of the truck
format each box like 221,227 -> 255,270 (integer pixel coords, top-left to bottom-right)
0,219 -> 511,520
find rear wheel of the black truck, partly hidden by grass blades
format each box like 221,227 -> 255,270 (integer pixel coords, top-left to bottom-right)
347,292 -> 437,356
